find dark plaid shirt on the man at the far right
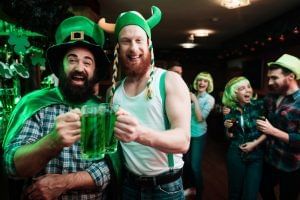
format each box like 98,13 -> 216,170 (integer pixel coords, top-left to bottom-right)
265,89 -> 300,172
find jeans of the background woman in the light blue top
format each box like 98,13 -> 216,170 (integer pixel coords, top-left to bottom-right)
184,134 -> 206,200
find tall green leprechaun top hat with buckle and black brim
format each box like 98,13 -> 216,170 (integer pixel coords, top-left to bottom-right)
47,16 -> 109,77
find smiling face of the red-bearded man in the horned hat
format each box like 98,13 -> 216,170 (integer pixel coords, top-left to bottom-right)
119,25 -> 151,77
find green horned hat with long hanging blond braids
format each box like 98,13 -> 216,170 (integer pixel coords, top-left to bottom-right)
98,6 -> 162,100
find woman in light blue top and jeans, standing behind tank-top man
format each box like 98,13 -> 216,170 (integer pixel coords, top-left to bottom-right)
186,72 -> 215,199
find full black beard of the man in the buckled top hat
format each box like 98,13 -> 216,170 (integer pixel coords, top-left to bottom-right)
58,71 -> 96,103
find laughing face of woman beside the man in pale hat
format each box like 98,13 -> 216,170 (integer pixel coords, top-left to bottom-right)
235,80 -> 253,105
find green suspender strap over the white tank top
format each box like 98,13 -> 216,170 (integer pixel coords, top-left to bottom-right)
159,71 -> 174,170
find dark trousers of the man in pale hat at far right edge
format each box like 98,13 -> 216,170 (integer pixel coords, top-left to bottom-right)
260,162 -> 300,200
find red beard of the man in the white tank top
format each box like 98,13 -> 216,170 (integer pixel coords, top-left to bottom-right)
119,53 -> 151,77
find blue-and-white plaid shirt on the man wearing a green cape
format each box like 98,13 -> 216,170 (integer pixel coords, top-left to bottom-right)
4,105 -> 110,200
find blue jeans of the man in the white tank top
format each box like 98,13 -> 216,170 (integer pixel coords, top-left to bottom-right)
122,178 -> 184,200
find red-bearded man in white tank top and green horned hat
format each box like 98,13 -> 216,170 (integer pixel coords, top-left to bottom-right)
98,6 -> 191,200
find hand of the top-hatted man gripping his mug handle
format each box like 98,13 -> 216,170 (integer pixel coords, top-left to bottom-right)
53,108 -> 81,147
